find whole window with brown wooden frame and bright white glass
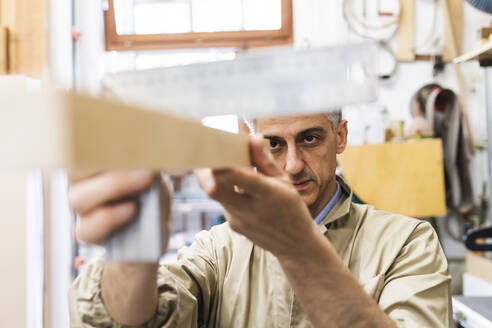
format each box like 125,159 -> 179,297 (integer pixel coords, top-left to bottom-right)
104,0 -> 293,50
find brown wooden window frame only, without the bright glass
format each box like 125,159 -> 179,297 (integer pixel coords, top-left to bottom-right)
104,0 -> 294,51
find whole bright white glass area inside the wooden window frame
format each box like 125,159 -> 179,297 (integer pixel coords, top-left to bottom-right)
114,0 -> 282,34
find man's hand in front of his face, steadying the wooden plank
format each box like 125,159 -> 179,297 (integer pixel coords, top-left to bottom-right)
196,135 -> 317,258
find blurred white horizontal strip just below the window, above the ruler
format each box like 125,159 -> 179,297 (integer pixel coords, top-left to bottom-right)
136,49 -> 236,69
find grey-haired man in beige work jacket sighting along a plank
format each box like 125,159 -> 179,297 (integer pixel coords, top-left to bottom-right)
69,114 -> 451,327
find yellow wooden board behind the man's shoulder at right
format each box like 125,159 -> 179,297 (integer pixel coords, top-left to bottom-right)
339,139 -> 446,217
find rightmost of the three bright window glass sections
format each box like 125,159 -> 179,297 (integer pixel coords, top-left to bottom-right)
243,0 -> 282,30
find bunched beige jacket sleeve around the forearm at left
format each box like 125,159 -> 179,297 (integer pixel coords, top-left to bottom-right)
69,231 -> 218,328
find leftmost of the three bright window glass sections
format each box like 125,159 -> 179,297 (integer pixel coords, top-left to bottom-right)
134,2 -> 191,34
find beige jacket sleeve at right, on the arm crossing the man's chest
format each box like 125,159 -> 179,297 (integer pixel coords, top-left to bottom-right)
379,221 -> 453,327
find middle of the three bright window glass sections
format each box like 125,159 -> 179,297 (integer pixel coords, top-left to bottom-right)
192,0 -> 242,32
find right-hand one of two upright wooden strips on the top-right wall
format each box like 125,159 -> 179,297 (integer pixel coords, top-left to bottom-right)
443,0 -> 464,61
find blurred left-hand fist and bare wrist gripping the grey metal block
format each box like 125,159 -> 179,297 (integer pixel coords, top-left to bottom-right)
68,171 -> 171,326
